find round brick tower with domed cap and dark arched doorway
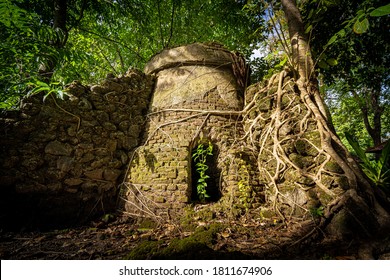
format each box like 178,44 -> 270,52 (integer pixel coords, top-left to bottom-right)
122,43 -> 258,218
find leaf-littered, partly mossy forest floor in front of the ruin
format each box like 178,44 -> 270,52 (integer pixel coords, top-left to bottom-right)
0,213 -> 390,260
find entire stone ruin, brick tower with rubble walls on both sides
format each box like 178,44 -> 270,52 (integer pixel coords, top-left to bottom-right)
0,43 -> 348,229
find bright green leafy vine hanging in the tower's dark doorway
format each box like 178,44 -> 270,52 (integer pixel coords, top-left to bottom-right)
192,141 -> 213,202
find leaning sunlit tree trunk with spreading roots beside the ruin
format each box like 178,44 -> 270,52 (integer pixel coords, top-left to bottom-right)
281,0 -> 389,235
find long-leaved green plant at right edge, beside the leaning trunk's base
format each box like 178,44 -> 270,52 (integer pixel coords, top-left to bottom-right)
345,133 -> 390,188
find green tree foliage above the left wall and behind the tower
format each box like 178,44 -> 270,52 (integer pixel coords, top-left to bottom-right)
0,0 -> 262,107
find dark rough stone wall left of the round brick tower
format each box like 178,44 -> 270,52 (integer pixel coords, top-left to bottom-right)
0,70 -> 154,229
